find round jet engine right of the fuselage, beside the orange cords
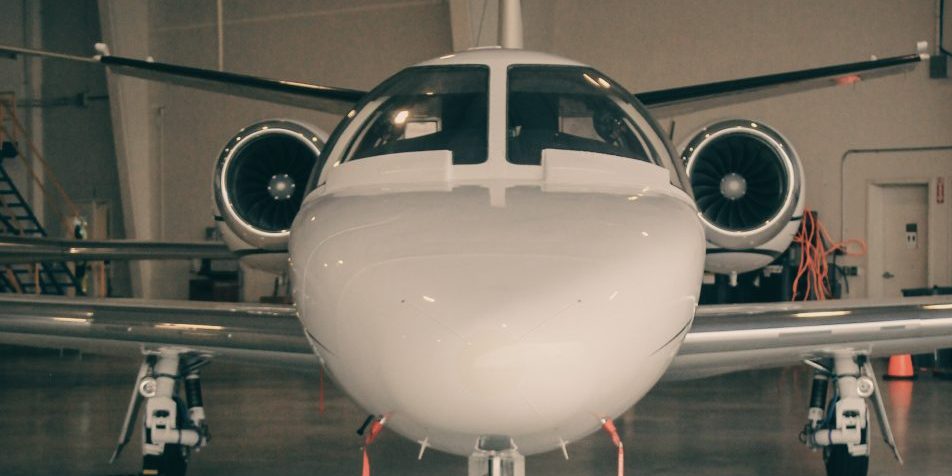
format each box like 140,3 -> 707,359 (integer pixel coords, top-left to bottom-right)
681,119 -> 803,274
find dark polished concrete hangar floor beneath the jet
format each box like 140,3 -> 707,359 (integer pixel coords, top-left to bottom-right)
0,347 -> 952,476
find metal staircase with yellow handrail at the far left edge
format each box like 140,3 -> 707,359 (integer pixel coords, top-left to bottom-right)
0,94 -> 82,295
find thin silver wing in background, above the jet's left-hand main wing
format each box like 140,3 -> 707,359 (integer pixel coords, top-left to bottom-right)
0,236 -> 241,265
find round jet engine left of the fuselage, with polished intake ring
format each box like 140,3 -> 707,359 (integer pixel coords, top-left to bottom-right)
214,119 -> 327,269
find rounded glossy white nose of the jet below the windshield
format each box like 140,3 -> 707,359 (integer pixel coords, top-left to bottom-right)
292,187 -> 704,454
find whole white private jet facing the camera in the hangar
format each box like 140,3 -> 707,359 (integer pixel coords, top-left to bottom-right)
0,2 -> 952,476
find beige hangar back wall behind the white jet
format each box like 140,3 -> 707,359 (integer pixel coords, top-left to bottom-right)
7,0 -> 952,297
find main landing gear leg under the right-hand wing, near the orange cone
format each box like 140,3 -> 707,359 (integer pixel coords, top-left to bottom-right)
800,353 -> 902,476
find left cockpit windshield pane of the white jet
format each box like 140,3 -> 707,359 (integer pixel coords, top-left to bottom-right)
344,66 -> 489,165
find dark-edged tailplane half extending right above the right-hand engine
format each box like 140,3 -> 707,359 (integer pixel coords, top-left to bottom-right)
635,49 -> 929,117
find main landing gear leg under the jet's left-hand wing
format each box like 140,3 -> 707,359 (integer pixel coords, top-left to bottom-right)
109,348 -> 211,476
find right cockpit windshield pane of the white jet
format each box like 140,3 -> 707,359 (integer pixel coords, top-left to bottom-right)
507,66 -> 652,165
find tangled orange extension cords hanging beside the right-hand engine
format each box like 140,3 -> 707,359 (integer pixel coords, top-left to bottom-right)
793,209 -> 867,301
